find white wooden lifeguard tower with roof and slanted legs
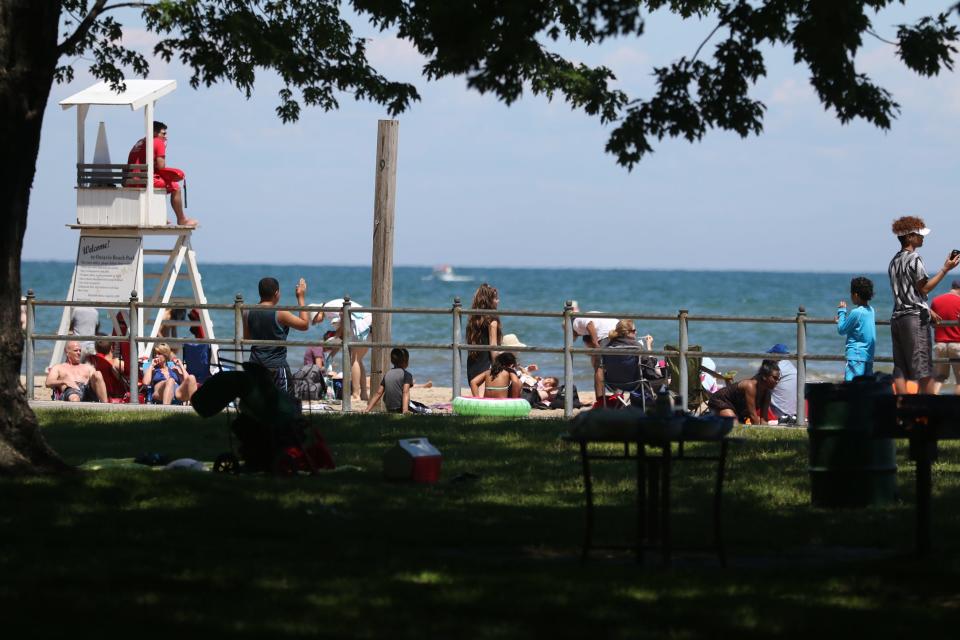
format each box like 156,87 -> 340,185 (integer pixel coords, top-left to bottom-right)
50,80 -> 217,366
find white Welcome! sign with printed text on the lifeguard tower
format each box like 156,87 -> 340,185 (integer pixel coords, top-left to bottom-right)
73,236 -> 141,302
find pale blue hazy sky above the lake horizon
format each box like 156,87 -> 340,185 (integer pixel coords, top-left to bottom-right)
23,2 -> 960,272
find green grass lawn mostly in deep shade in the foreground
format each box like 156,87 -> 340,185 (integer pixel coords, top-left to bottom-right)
0,411 -> 960,638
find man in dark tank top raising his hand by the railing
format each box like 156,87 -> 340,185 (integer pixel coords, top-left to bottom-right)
243,278 -> 310,392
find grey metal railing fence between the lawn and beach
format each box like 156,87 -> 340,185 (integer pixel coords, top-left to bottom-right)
21,290 -> 958,425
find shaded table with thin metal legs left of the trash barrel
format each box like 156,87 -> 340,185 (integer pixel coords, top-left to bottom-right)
563,410 -> 742,567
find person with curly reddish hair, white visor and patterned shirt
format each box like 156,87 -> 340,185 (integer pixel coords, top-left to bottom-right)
887,216 -> 960,394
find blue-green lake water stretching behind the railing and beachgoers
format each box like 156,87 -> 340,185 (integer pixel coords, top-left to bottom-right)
22,262 -> 908,388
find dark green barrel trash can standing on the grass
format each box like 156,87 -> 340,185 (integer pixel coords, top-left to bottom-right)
805,376 -> 897,507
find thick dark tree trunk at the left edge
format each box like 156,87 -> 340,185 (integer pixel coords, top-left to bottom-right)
0,0 -> 70,475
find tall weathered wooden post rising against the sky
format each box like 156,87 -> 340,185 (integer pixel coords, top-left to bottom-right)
368,120 -> 400,404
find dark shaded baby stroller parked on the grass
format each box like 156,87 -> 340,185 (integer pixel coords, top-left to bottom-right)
192,362 -> 336,475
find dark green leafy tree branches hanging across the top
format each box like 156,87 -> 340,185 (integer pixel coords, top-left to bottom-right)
57,0 -> 960,168
